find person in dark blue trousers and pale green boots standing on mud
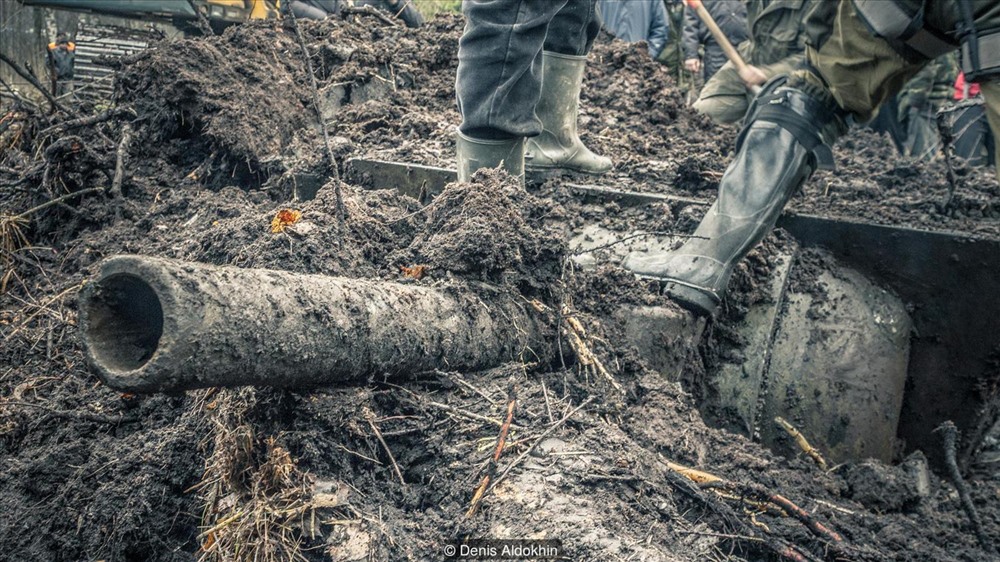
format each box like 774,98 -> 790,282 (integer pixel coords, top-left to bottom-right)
455,0 -> 611,181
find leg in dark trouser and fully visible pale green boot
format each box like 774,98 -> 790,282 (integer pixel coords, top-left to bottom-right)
525,0 -> 611,174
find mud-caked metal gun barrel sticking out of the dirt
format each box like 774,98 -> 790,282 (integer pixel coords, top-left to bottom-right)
80,256 -> 547,392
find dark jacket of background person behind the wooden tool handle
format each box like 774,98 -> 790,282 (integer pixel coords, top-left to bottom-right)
683,0 -> 747,80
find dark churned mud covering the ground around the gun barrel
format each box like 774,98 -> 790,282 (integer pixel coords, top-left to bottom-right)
0,12 -> 1000,561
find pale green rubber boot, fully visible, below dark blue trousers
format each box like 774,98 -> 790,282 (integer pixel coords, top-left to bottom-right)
525,51 -> 611,174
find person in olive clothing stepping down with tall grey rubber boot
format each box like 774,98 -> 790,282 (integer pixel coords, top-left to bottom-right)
624,0 -> 1000,315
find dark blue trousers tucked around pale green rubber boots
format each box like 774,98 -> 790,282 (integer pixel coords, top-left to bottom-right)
455,0 -> 601,139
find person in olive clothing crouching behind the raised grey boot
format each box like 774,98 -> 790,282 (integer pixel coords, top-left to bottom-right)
693,0 -> 821,123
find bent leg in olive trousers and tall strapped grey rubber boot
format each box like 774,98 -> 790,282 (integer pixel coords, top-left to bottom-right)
624,0 -> 920,314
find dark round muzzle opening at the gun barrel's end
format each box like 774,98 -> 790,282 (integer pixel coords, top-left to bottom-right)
84,274 -> 163,372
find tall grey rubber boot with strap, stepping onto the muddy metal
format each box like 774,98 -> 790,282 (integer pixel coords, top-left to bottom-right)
623,76 -> 846,315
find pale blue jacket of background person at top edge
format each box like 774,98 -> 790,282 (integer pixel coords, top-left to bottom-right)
597,0 -> 670,59
